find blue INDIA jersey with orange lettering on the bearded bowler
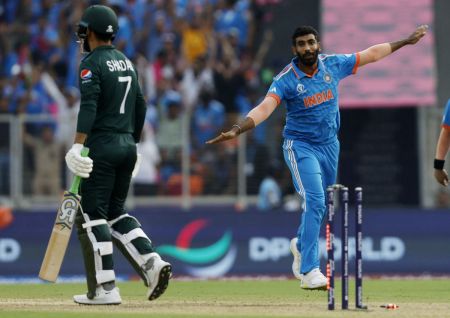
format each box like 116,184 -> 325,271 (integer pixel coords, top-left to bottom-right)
266,53 -> 359,144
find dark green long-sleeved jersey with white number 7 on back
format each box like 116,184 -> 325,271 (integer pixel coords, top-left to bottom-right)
77,45 -> 146,143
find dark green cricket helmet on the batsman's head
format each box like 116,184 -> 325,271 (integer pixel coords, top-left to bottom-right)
77,5 -> 119,40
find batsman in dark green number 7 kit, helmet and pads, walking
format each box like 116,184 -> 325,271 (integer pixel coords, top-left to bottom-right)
65,5 -> 172,305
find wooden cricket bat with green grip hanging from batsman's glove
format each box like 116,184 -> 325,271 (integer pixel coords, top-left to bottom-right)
39,147 -> 89,283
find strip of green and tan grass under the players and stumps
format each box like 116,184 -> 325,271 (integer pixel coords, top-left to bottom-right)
0,278 -> 450,318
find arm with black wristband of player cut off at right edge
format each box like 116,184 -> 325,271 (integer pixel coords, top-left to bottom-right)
434,99 -> 450,187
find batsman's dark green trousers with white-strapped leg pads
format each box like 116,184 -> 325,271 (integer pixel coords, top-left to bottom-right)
76,134 -> 153,298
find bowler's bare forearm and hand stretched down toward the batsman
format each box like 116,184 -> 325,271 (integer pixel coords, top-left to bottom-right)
206,96 -> 278,144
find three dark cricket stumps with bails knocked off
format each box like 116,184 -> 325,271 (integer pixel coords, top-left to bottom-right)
326,184 -> 367,310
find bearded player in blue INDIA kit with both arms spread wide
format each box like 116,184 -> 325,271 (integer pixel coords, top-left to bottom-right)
207,25 -> 428,289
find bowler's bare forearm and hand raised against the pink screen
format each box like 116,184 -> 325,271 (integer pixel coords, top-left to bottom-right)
359,25 -> 428,67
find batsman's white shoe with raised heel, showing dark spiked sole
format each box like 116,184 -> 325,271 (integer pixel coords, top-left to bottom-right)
144,253 -> 172,300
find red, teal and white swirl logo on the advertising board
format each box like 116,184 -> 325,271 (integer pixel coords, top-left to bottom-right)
157,219 -> 237,278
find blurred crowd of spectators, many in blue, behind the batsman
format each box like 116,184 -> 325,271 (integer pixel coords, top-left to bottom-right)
0,0 -> 296,204
